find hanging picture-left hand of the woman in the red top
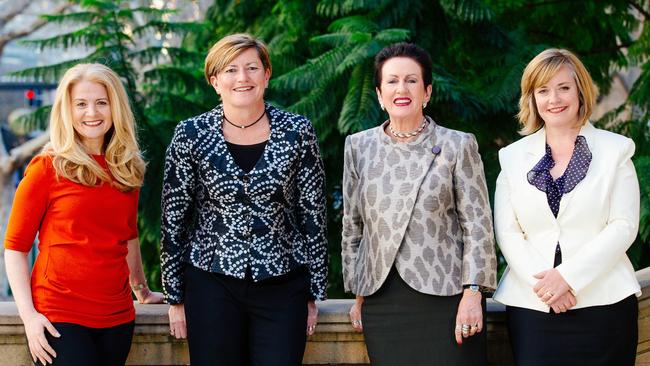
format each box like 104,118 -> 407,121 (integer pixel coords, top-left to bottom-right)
23,311 -> 61,365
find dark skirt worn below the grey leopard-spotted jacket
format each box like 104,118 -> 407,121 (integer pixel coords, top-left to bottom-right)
361,267 -> 487,366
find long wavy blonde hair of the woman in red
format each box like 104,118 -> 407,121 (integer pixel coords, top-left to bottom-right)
45,64 -> 145,191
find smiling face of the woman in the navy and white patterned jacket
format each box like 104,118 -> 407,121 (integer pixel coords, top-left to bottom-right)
210,48 -> 271,108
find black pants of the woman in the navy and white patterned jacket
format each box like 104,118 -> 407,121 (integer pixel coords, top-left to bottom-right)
185,266 -> 309,366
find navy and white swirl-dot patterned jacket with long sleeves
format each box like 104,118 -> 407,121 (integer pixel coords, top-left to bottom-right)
160,104 -> 327,304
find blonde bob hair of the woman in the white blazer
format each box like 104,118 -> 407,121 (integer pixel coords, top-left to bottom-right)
517,48 -> 598,135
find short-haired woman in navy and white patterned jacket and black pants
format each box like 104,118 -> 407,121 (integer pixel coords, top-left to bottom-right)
161,34 -> 327,366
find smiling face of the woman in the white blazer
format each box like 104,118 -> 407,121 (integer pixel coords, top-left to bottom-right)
534,66 -> 580,127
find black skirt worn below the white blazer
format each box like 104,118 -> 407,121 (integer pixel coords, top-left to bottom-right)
506,295 -> 639,366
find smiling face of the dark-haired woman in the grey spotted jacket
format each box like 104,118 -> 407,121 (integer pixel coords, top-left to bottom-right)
377,57 -> 431,122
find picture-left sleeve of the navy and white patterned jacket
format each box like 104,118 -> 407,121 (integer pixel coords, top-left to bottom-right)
160,122 -> 196,304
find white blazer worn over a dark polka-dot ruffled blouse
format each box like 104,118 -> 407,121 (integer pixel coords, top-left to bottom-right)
494,123 -> 641,312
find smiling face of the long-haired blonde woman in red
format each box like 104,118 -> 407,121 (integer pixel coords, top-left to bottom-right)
70,80 -> 113,154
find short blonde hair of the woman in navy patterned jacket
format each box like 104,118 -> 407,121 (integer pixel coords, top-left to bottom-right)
205,33 -> 271,83
